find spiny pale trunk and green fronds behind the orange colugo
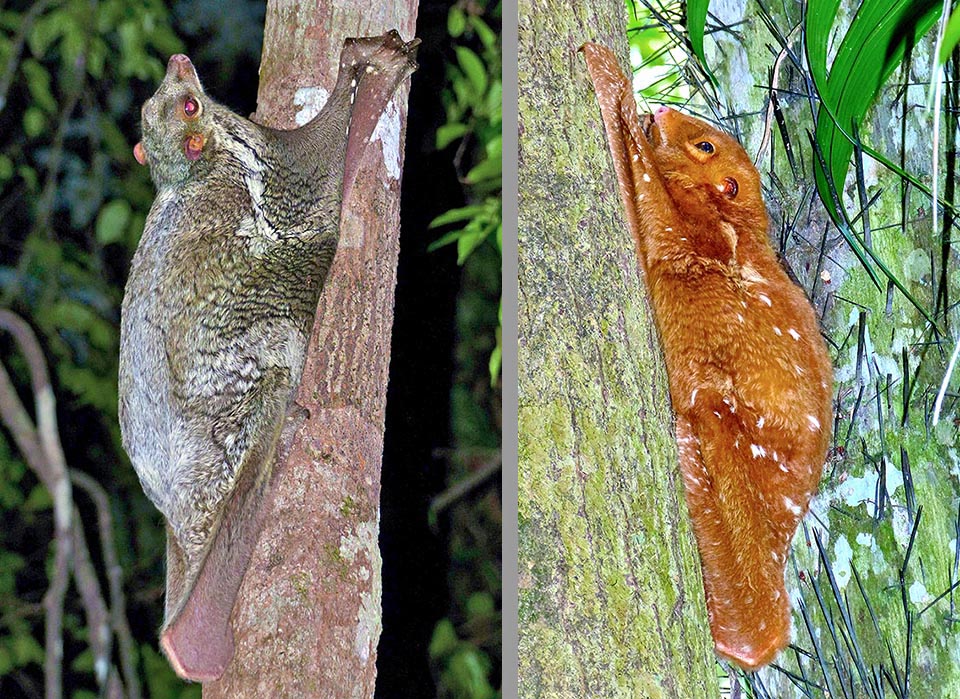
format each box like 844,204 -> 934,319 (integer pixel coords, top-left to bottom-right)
626,0 -> 960,699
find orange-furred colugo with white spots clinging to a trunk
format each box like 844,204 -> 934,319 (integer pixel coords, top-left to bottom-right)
583,44 -> 832,670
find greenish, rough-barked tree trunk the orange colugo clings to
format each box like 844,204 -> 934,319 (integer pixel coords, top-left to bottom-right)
519,0 -> 718,699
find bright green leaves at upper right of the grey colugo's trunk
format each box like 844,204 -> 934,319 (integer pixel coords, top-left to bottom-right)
429,2 -> 503,383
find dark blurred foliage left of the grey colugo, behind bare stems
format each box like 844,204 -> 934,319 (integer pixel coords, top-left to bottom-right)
0,0 -> 255,698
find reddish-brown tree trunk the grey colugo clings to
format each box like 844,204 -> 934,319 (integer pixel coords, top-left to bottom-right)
203,0 -> 417,699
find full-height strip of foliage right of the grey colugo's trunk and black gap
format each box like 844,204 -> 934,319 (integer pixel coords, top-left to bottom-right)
430,0 -> 503,699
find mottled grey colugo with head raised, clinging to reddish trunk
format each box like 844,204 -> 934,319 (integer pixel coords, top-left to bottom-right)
120,31 -> 419,680
